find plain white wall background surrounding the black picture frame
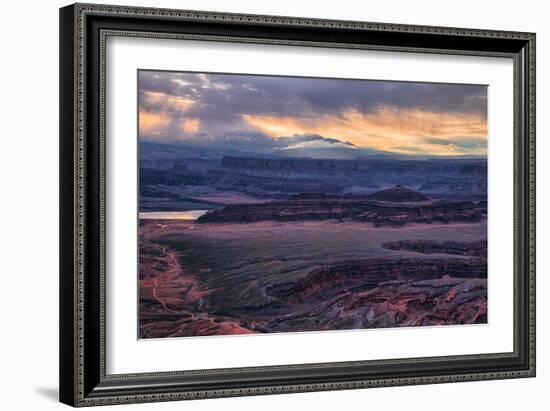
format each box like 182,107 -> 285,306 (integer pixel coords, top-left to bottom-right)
0,0 -> 550,411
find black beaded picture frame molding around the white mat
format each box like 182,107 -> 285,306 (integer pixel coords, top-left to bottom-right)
59,4 -> 535,406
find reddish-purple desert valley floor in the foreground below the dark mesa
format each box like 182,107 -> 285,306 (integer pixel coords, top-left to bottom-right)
139,217 -> 487,338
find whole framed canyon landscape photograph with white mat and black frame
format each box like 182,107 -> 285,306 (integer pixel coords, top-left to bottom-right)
60,4 -> 535,406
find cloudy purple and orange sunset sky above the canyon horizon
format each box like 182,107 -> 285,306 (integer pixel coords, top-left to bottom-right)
138,71 -> 487,156
